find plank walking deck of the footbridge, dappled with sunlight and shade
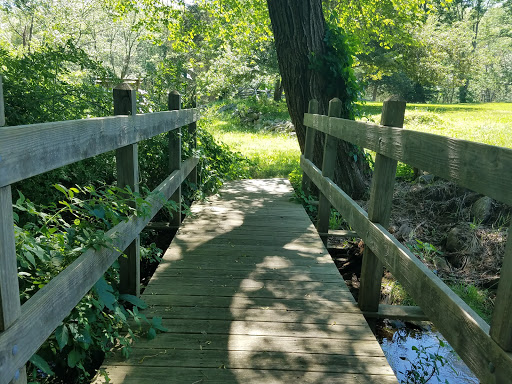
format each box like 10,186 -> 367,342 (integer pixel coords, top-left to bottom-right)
97,179 -> 396,384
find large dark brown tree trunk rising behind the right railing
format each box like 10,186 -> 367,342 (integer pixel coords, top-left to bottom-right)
267,0 -> 368,198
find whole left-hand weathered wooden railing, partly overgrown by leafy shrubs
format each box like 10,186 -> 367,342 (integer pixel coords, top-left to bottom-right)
0,78 -> 199,384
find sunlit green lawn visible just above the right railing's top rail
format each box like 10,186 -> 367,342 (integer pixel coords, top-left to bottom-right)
362,102 -> 512,148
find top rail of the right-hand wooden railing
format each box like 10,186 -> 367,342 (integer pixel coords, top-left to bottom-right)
304,114 -> 512,205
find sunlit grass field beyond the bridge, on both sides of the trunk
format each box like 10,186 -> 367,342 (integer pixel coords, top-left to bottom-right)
205,100 -> 512,178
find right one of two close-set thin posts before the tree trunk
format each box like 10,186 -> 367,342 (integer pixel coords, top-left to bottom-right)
314,99 -> 342,245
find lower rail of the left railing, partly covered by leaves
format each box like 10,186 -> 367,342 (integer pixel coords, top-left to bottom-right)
0,159 -> 197,384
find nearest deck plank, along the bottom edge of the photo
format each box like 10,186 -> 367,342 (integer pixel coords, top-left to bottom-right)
94,366 -> 396,384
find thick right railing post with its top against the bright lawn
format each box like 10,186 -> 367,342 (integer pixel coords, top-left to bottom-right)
358,96 -> 405,312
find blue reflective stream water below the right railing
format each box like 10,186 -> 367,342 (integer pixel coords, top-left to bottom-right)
377,320 -> 479,384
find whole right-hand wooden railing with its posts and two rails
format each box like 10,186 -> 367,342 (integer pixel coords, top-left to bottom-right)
301,99 -> 512,384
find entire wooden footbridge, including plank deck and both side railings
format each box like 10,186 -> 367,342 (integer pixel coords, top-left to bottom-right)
0,82 -> 512,384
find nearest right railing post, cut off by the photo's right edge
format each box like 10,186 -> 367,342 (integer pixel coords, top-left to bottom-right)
491,225 -> 512,352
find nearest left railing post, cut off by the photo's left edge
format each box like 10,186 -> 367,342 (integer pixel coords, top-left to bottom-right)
0,76 -> 27,384
